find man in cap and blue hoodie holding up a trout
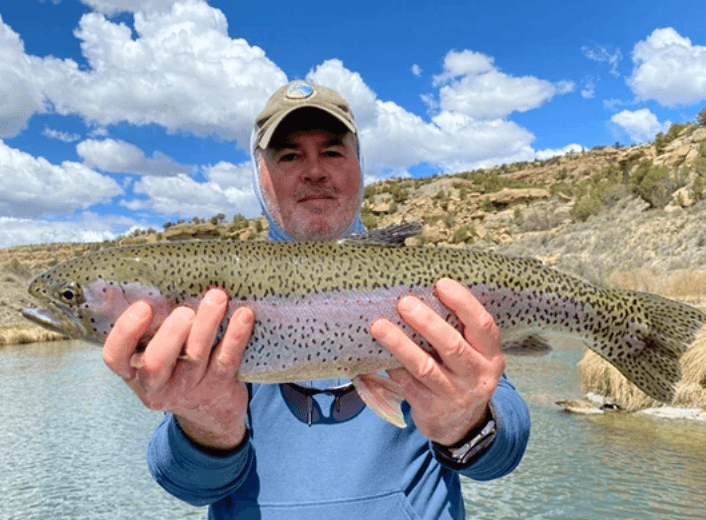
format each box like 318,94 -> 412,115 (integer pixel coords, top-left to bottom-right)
103,81 -> 529,520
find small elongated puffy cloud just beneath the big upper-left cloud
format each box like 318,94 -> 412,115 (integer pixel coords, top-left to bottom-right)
76,139 -> 192,175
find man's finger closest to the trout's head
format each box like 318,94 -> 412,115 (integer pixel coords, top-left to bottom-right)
103,301 -> 152,380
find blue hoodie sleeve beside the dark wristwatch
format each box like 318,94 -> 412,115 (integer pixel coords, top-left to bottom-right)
434,374 -> 530,480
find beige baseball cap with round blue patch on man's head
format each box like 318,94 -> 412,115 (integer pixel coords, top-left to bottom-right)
254,80 -> 357,150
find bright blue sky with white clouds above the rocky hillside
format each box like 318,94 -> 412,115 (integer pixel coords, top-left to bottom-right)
0,0 -> 706,247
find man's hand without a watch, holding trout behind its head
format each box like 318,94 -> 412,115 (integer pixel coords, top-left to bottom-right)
103,289 -> 254,450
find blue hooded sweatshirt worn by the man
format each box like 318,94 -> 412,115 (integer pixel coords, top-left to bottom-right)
147,128 -> 530,520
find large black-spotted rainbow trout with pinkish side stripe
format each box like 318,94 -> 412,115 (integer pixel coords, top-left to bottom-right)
23,225 -> 706,425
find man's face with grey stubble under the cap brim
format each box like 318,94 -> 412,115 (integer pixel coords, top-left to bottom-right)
259,130 -> 361,240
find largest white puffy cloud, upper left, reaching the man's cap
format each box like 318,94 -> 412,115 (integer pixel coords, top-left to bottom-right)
0,0 -> 287,148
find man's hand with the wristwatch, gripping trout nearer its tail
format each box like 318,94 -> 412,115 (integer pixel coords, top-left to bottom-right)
371,279 -> 505,446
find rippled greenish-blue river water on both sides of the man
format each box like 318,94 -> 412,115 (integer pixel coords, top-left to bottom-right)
0,341 -> 706,520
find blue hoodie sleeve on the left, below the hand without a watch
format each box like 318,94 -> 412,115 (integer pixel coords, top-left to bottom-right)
147,414 -> 253,506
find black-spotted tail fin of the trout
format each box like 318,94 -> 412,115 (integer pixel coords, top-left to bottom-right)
599,291 -> 706,403
